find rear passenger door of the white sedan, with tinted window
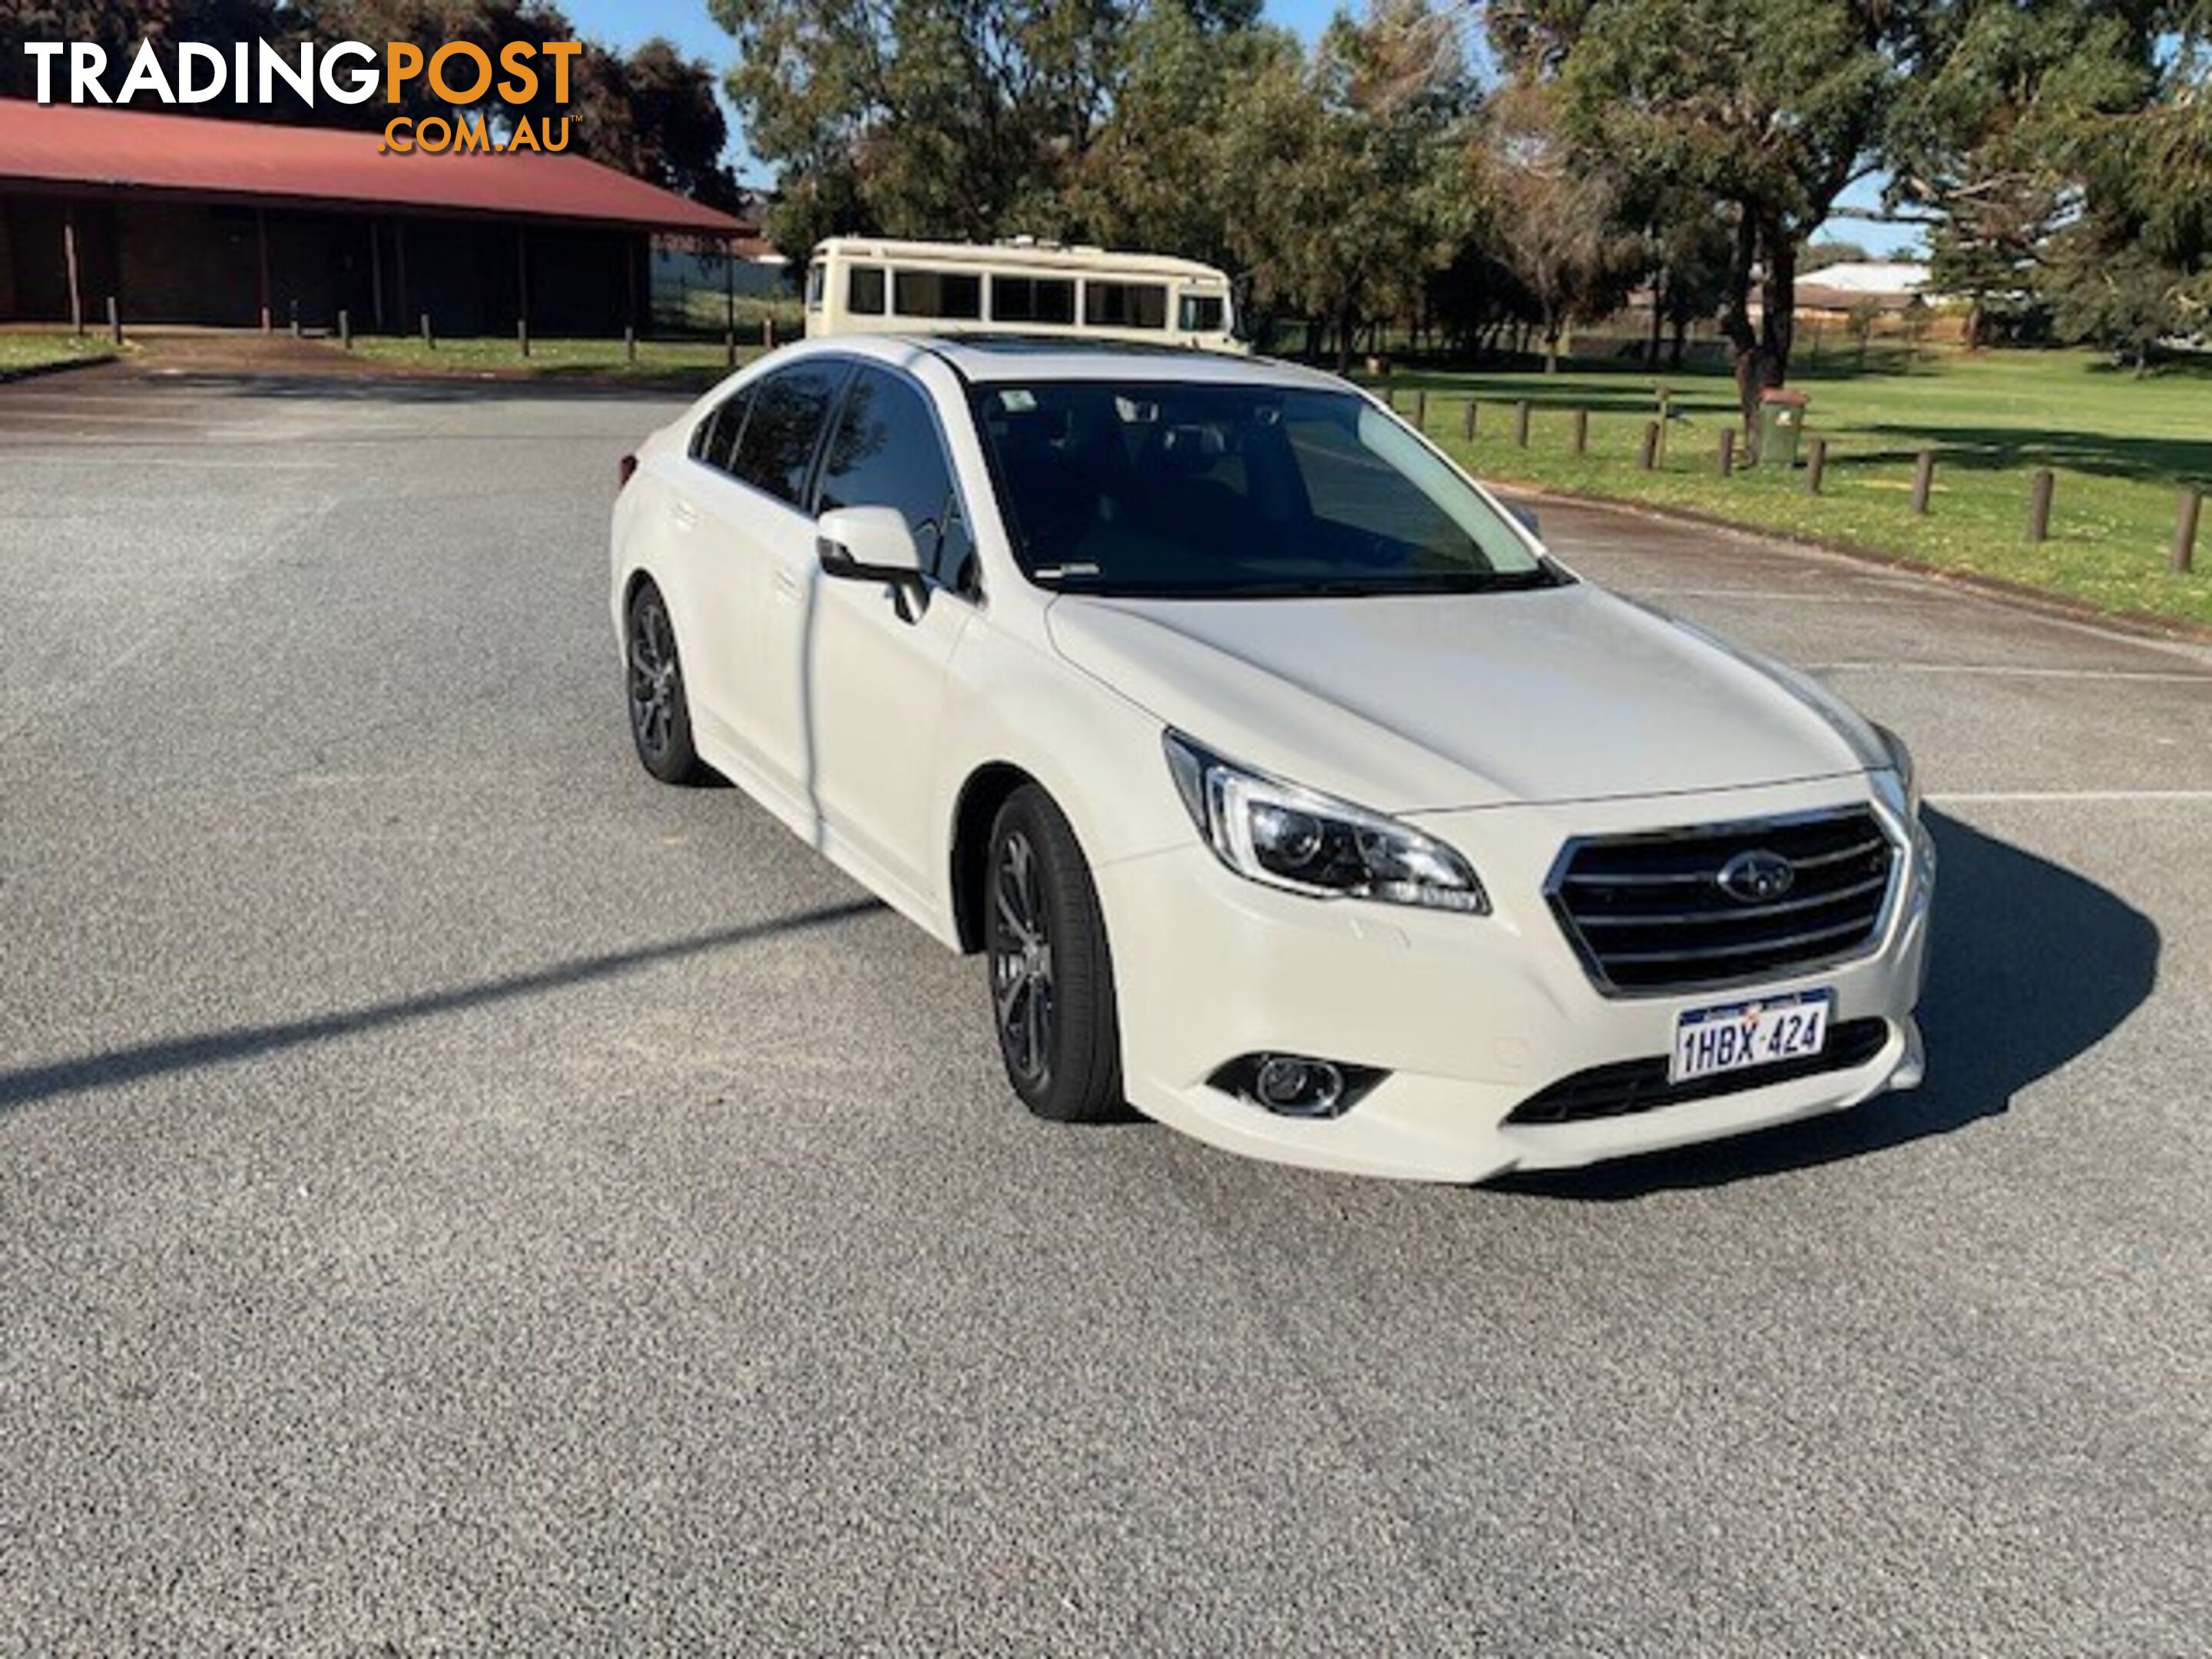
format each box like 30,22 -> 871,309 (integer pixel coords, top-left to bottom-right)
690,356 -> 852,814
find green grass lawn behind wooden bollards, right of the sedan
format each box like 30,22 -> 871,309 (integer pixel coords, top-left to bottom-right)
1389,349 -> 2212,621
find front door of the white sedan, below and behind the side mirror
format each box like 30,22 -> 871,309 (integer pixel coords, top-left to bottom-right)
799,363 -> 975,894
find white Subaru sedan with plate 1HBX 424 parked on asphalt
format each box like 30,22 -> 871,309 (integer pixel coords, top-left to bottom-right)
613,336 -> 1933,1181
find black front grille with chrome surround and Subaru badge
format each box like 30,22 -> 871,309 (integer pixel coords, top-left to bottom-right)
1548,807 -> 1898,995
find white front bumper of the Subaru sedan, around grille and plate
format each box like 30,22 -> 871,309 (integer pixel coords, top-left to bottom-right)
1095,779 -> 1933,1181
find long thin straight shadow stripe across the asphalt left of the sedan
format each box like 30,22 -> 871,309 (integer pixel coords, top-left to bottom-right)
0,898 -> 885,1113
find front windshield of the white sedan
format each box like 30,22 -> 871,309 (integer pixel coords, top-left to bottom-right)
973,380 -> 1566,598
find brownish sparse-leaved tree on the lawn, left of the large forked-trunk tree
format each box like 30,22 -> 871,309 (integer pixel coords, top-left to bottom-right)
1469,84 -> 1644,374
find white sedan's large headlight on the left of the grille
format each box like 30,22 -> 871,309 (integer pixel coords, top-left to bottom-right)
1161,732 -> 1491,916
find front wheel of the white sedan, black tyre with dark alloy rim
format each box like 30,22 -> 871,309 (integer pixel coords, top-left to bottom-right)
985,783 -> 1128,1124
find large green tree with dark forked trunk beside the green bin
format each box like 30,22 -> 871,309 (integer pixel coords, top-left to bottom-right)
1488,0 -> 1938,425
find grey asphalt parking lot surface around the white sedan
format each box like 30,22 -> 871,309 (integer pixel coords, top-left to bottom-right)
0,369 -> 2212,1654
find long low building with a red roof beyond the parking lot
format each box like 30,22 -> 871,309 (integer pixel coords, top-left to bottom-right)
0,100 -> 761,334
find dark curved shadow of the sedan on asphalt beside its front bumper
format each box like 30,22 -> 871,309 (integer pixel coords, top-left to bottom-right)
1493,810 -> 2159,1201
